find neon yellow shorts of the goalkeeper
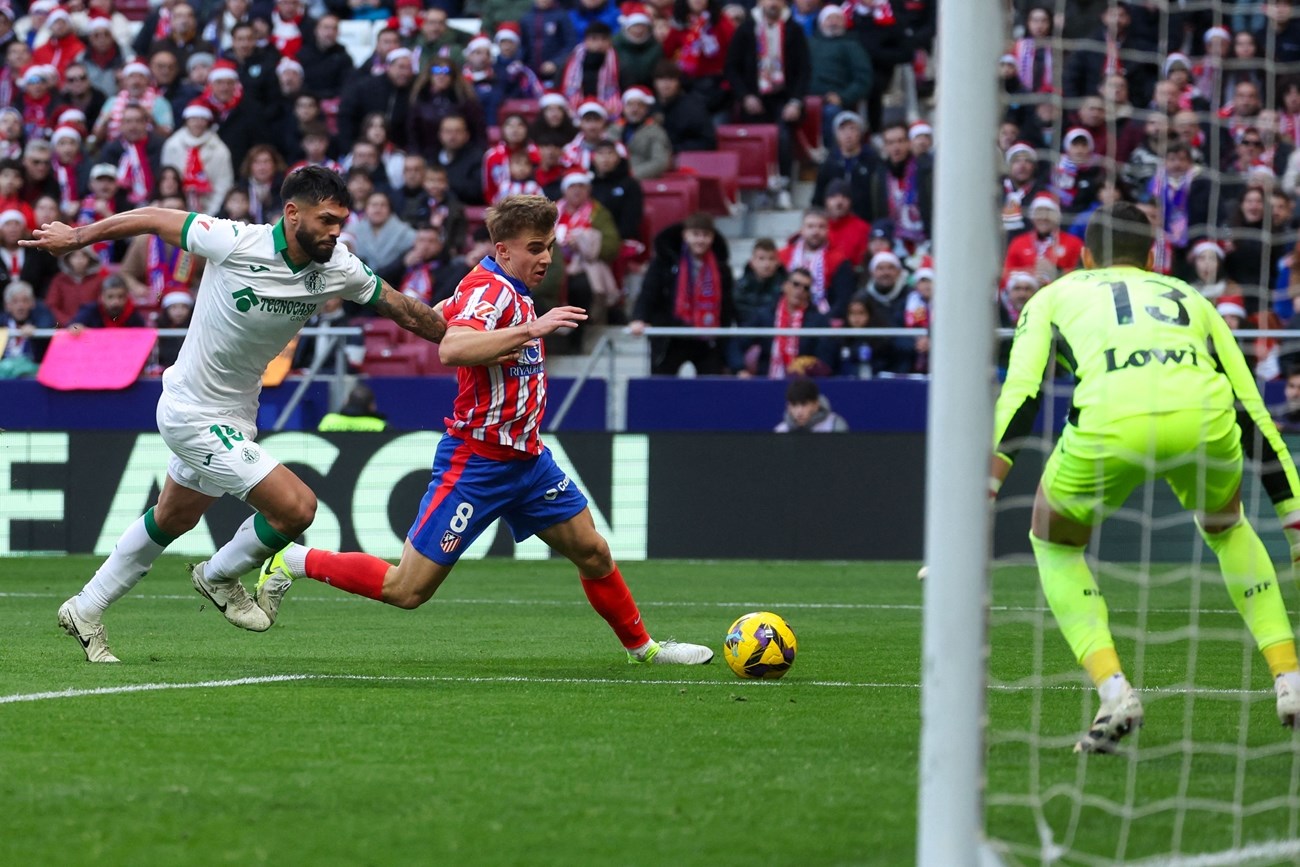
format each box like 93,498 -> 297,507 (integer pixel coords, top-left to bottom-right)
1043,409 -> 1242,525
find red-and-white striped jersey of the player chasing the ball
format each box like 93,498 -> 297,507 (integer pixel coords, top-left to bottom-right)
442,256 -> 546,460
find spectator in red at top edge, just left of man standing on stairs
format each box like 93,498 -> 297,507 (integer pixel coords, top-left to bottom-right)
663,0 -> 736,114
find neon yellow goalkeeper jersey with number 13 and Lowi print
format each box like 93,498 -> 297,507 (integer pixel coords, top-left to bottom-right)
995,266 -> 1278,460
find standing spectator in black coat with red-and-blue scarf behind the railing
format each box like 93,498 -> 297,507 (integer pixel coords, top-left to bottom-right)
632,213 -> 736,376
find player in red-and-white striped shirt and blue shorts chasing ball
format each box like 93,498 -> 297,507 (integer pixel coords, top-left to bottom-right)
256,196 -> 714,664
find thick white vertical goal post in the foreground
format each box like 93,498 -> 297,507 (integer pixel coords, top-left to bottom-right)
917,0 -> 1005,867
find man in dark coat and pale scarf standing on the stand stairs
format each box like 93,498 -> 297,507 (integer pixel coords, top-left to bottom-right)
727,0 -> 806,208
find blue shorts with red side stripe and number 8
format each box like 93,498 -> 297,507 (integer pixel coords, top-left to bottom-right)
407,434 -> 586,565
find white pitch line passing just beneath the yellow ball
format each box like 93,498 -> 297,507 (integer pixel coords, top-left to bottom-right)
0,675 -> 1273,705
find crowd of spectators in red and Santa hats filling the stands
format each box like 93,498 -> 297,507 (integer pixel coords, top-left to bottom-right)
10,0 -> 1300,387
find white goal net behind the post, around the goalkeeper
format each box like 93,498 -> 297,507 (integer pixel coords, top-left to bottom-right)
977,0 -> 1300,866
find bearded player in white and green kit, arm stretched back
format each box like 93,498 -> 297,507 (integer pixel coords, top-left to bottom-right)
22,166 -> 446,662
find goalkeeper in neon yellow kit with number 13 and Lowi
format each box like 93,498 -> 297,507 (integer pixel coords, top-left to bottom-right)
991,203 -> 1300,753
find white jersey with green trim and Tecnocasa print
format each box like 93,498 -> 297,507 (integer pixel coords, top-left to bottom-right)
163,213 -> 382,417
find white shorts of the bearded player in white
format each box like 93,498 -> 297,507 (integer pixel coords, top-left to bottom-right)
157,391 -> 280,499
